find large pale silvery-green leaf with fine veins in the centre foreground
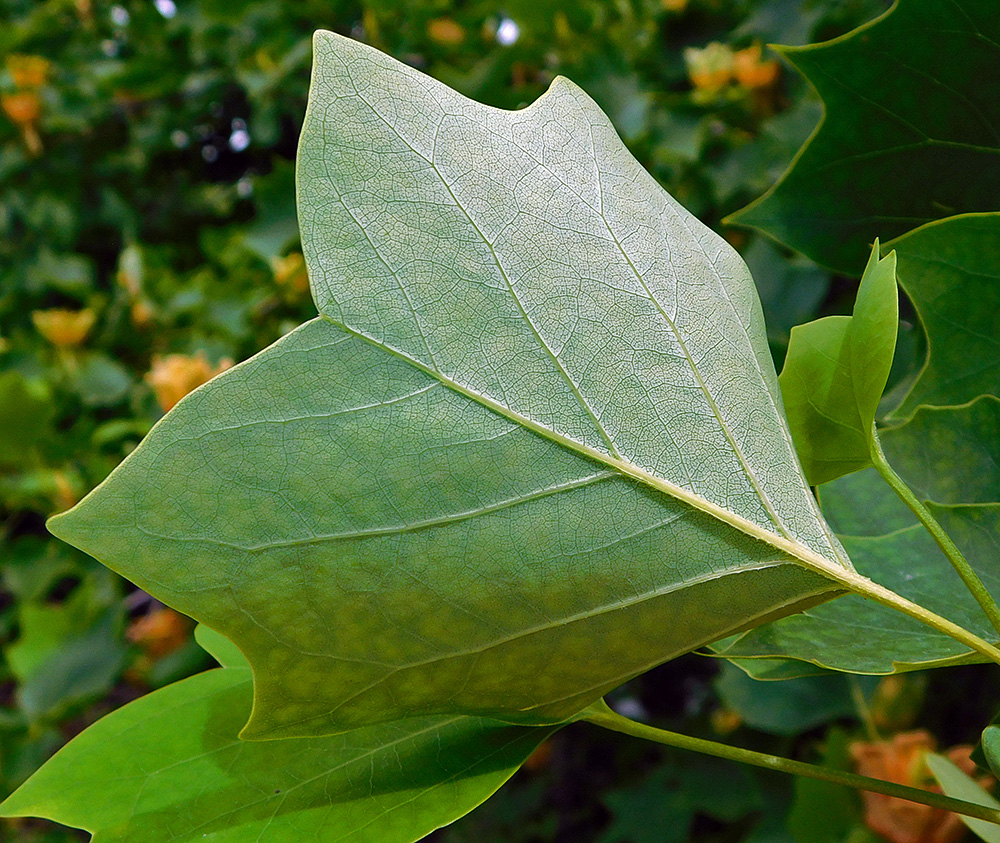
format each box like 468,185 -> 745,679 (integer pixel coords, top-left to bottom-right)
52,32 -> 855,737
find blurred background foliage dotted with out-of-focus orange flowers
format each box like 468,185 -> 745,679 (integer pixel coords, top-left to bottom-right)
0,0 -> 1000,843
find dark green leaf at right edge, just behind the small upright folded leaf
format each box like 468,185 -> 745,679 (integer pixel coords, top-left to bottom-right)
886,214 -> 1000,418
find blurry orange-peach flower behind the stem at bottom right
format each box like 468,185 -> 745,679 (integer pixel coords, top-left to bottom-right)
850,730 -> 990,843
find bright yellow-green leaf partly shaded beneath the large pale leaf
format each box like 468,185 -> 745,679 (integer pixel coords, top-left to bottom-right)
0,668 -> 552,843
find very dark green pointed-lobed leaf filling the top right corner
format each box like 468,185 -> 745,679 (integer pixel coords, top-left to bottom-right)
728,0 -> 1000,272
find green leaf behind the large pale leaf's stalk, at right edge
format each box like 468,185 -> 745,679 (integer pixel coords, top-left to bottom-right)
721,469 -> 1000,678
